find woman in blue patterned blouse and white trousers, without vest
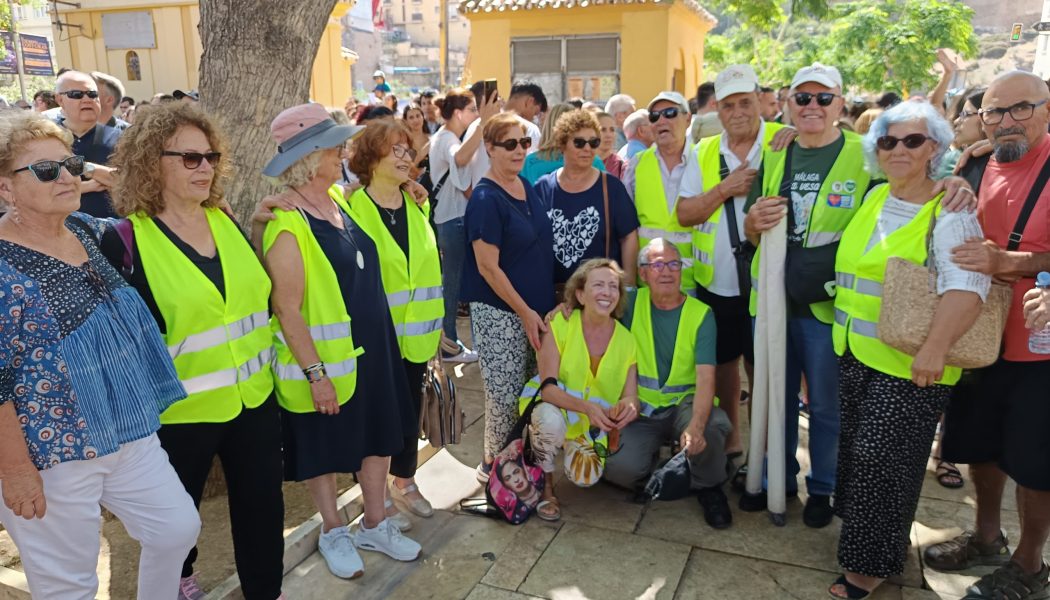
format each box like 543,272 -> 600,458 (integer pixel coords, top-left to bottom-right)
0,110 -> 201,600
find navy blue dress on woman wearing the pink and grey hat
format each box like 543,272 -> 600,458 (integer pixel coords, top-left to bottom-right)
281,209 -> 419,481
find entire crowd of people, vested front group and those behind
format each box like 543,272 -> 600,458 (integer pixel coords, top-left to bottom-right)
0,50 -> 1050,600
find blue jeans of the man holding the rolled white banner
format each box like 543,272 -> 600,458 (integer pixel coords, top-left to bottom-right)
752,317 -> 839,496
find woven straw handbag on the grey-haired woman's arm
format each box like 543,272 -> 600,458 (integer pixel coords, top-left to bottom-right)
877,211 -> 1013,369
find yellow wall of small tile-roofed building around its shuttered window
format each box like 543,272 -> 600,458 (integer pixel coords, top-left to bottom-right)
467,4 -> 711,103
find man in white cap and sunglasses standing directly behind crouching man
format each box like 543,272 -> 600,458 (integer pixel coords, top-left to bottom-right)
624,91 -> 696,295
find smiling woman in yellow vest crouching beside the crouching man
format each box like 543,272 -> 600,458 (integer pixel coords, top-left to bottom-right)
520,258 -> 639,520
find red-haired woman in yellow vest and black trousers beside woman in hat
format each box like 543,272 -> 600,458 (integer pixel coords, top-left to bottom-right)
350,119 -> 445,531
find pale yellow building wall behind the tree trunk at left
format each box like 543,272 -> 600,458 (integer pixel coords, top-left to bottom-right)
55,0 -> 352,107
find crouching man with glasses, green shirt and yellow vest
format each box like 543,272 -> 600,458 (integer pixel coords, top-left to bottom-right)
605,237 -> 733,529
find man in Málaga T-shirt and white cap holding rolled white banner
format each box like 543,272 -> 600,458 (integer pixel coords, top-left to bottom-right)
740,63 -> 974,527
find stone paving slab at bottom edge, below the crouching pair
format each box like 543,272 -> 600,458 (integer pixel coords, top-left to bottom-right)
519,522 -> 690,600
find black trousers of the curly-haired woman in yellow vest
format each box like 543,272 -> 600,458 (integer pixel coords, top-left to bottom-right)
158,396 -> 285,600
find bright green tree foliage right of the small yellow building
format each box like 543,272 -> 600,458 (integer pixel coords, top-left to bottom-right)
705,0 -> 977,91
